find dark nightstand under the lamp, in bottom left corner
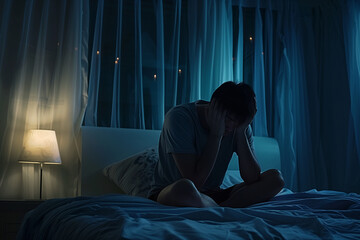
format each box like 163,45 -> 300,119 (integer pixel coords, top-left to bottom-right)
0,200 -> 44,240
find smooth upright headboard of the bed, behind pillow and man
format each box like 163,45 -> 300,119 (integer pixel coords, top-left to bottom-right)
81,126 -> 280,196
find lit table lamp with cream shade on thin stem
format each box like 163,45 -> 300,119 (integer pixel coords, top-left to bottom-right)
19,129 -> 61,199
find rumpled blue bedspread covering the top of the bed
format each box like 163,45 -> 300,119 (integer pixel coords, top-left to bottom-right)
18,190 -> 360,240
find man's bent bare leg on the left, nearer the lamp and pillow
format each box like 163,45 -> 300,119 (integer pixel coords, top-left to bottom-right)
157,178 -> 218,207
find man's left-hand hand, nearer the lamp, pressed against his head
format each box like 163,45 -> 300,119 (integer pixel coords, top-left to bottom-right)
207,99 -> 226,137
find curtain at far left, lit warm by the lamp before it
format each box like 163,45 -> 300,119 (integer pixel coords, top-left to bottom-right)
0,0 -> 89,199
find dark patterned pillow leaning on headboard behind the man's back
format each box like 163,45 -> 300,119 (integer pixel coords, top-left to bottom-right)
103,147 -> 159,197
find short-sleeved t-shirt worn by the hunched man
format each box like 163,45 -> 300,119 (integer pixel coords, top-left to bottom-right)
148,101 -> 253,196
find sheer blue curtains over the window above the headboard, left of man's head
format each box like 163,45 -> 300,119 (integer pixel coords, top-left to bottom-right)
84,0 -> 233,129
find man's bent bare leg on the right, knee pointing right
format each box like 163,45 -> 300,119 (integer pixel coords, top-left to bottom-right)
220,169 -> 284,207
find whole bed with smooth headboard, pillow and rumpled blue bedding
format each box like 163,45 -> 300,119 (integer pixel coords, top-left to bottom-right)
18,127 -> 360,240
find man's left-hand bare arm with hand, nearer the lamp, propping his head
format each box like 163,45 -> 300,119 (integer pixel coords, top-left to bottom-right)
172,101 -> 226,189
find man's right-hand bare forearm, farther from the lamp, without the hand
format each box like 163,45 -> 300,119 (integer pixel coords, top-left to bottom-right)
236,124 -> 261,184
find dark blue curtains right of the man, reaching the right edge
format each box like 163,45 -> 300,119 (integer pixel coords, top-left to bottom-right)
233,0 -> 360,192
